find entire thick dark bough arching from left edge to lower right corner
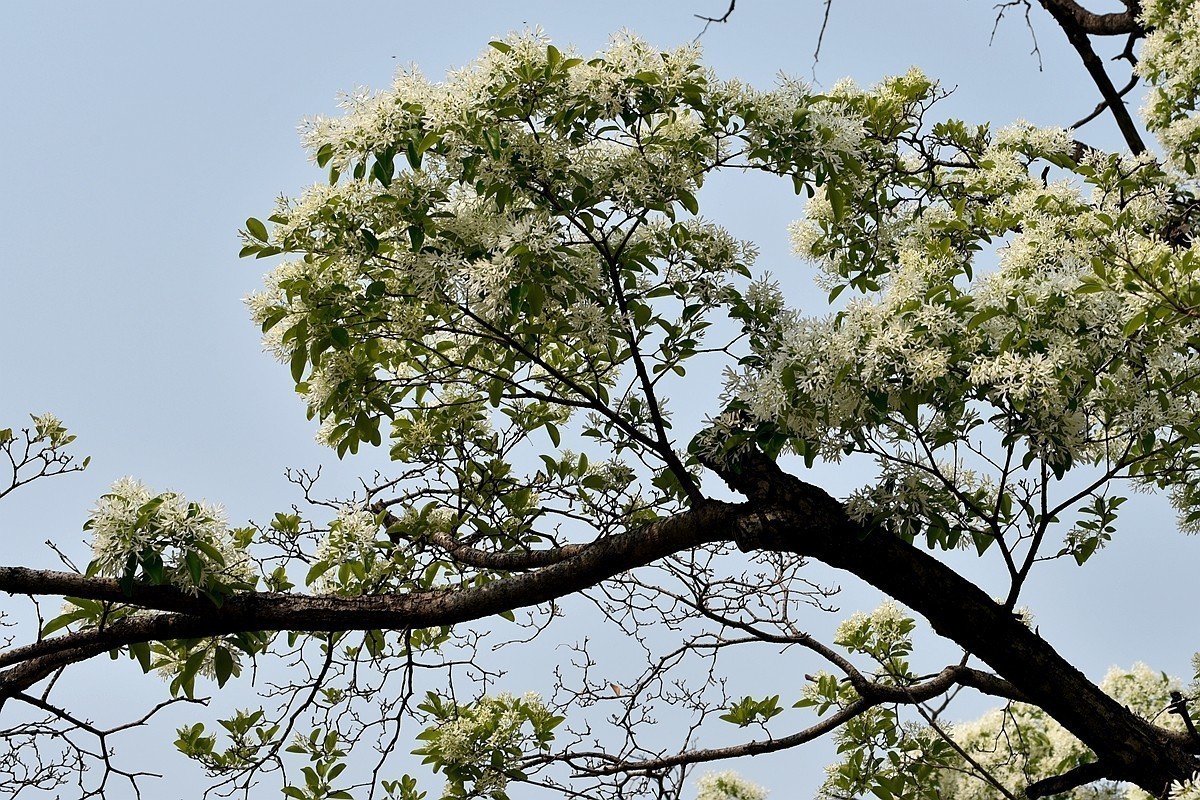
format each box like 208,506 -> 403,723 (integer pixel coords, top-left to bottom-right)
0,451 -> 1195,790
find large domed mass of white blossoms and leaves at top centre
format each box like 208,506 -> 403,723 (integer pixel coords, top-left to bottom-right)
255,30 -> 902,462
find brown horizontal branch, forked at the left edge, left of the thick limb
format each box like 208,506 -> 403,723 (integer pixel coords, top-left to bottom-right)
0,501 -> 742,698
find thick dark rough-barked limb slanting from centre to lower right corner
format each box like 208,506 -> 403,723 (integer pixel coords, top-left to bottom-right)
710,453 -> 1198,796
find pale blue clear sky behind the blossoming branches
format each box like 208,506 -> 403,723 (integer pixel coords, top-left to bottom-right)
0,0 -> 1200,798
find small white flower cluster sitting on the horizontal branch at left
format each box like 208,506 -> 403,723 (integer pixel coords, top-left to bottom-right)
85,477 -> 256,591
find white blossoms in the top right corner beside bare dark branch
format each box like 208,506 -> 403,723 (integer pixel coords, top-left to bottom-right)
1138,0 -> 1200,176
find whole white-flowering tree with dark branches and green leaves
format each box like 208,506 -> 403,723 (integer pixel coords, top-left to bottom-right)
0,0 -> 1200,800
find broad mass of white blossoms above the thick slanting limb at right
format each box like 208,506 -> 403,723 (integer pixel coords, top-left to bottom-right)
726,115 -> 1200,491
